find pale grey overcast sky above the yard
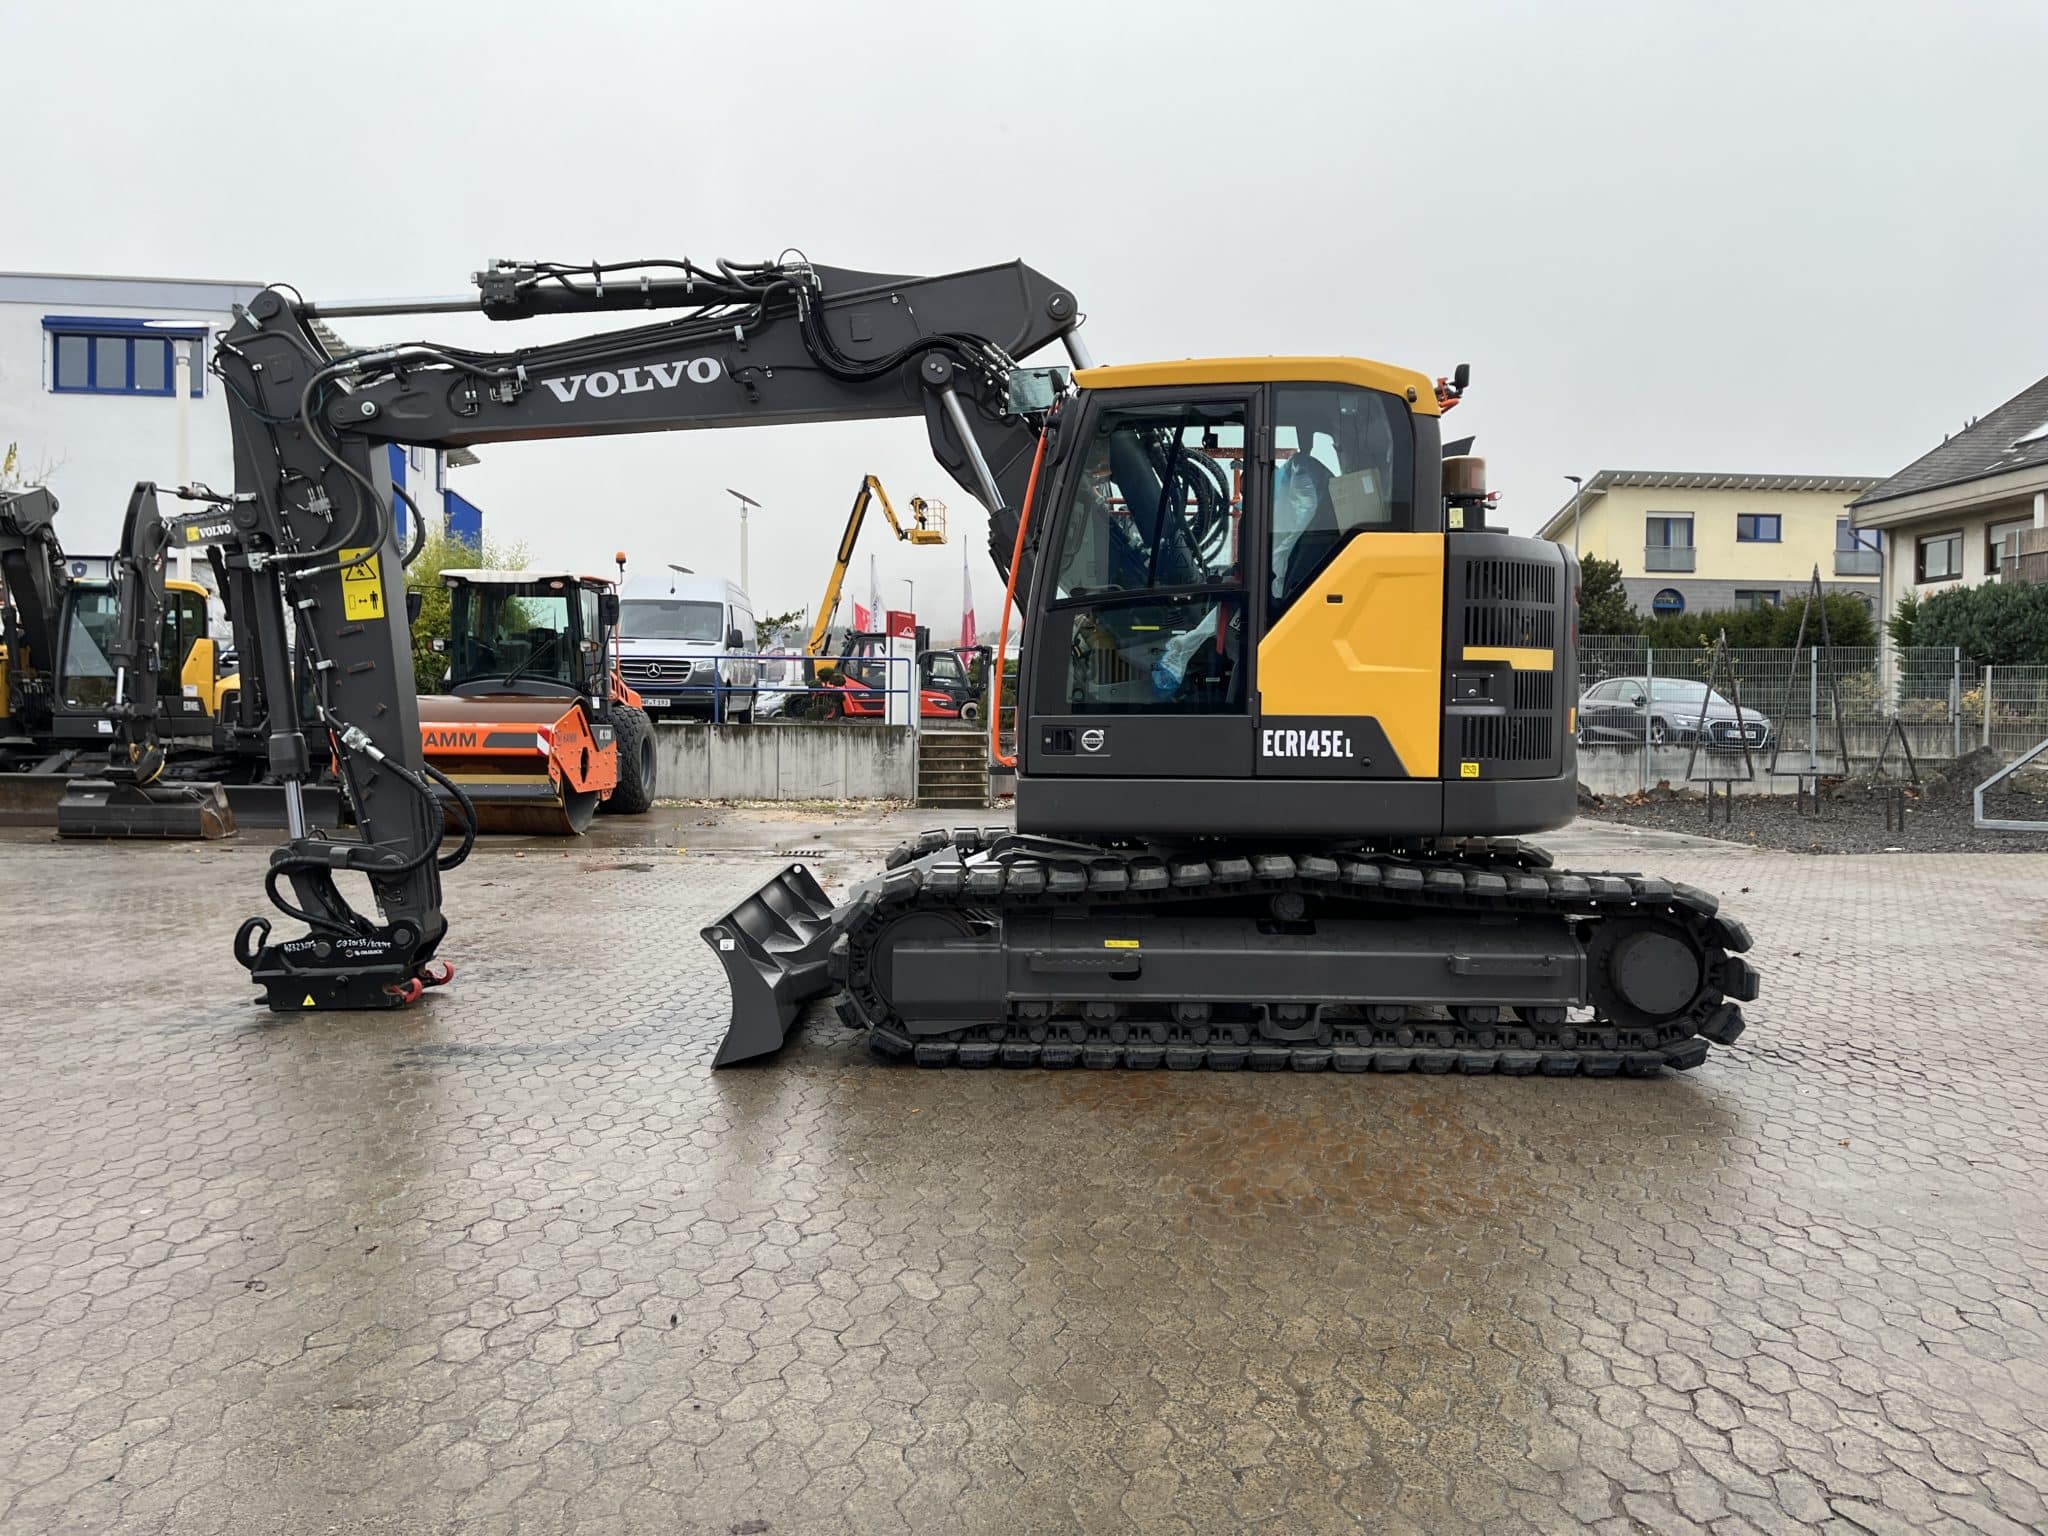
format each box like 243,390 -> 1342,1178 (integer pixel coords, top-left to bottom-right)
0,0 -> 2048,629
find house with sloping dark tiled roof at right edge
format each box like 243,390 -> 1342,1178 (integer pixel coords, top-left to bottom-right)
1851,379 -> 2048,612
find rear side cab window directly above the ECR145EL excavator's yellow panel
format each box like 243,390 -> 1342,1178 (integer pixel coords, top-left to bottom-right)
1266,385 -> 1415,625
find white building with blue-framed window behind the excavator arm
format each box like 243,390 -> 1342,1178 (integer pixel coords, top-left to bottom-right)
0,272 -> 483,580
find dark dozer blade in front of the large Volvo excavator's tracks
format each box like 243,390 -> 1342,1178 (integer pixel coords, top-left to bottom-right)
705,864 -> 840,1067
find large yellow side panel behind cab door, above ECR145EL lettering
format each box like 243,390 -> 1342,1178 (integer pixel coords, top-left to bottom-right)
1260,532 -> 1444,778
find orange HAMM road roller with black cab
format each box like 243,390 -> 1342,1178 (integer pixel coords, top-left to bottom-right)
420,569 -> 655,836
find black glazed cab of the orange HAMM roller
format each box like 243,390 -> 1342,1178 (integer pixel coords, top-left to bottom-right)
440,569 -> 618,700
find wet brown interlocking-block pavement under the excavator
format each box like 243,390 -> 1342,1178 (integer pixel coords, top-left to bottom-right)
0,809 -> 2048,1536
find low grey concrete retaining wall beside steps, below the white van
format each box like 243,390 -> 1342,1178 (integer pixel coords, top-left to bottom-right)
653,721 -> 918,801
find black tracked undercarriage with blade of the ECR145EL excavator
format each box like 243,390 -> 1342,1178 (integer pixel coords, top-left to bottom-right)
705,829 -> 1757,1077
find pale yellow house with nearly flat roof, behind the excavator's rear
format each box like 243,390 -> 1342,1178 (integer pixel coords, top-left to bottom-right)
1538,469 -> 1884,614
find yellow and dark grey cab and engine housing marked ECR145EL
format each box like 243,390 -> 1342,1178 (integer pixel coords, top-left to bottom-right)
1018,358 -> 1575,838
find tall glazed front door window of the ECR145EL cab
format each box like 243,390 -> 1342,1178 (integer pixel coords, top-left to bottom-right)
1040,399 -> 1249,715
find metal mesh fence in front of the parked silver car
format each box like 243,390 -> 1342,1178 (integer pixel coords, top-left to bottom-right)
1579,635 -> 2048,778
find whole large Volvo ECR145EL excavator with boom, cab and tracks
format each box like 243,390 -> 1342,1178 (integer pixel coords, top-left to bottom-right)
195,256 -> 1757,1075
